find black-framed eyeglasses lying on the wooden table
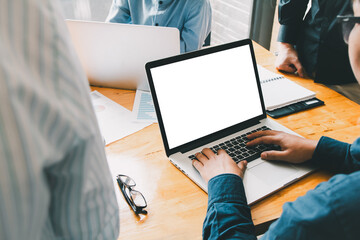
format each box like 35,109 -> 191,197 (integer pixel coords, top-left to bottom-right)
116,175 -> 147,214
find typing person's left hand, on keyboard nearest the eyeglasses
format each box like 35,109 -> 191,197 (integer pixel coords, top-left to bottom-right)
192,148 -> 247,182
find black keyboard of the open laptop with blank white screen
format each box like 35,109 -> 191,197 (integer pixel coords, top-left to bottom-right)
189,126 -> 279,163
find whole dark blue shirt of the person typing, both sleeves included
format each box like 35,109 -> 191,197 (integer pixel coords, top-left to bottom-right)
203,137 -> 360,240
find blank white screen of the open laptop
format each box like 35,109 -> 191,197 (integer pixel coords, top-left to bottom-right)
151,45 -> 262,149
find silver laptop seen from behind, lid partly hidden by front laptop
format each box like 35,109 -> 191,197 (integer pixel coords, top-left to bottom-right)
66,20 -> 180,90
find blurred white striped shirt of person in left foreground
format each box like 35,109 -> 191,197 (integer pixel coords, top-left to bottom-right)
0,0 -> 119,240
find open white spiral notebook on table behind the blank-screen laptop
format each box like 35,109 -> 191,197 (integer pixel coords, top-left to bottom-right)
258,65 -> 316,111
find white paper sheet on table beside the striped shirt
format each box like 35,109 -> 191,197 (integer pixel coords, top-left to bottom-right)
91,91 -> 151,145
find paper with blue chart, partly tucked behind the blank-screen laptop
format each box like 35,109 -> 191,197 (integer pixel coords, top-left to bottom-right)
133,90 -> 157,123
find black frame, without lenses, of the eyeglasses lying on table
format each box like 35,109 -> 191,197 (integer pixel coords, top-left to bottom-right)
116,174 -> 147,215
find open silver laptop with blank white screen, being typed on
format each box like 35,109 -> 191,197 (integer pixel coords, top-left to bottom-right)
146,39 -> 312,204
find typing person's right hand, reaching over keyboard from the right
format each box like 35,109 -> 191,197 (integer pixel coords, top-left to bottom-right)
247,130 -> 318,163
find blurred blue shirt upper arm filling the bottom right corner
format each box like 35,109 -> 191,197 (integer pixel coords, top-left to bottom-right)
261,172 -> 360,240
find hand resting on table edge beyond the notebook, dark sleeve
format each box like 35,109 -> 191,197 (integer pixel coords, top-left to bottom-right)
275,43 -> 306,77
